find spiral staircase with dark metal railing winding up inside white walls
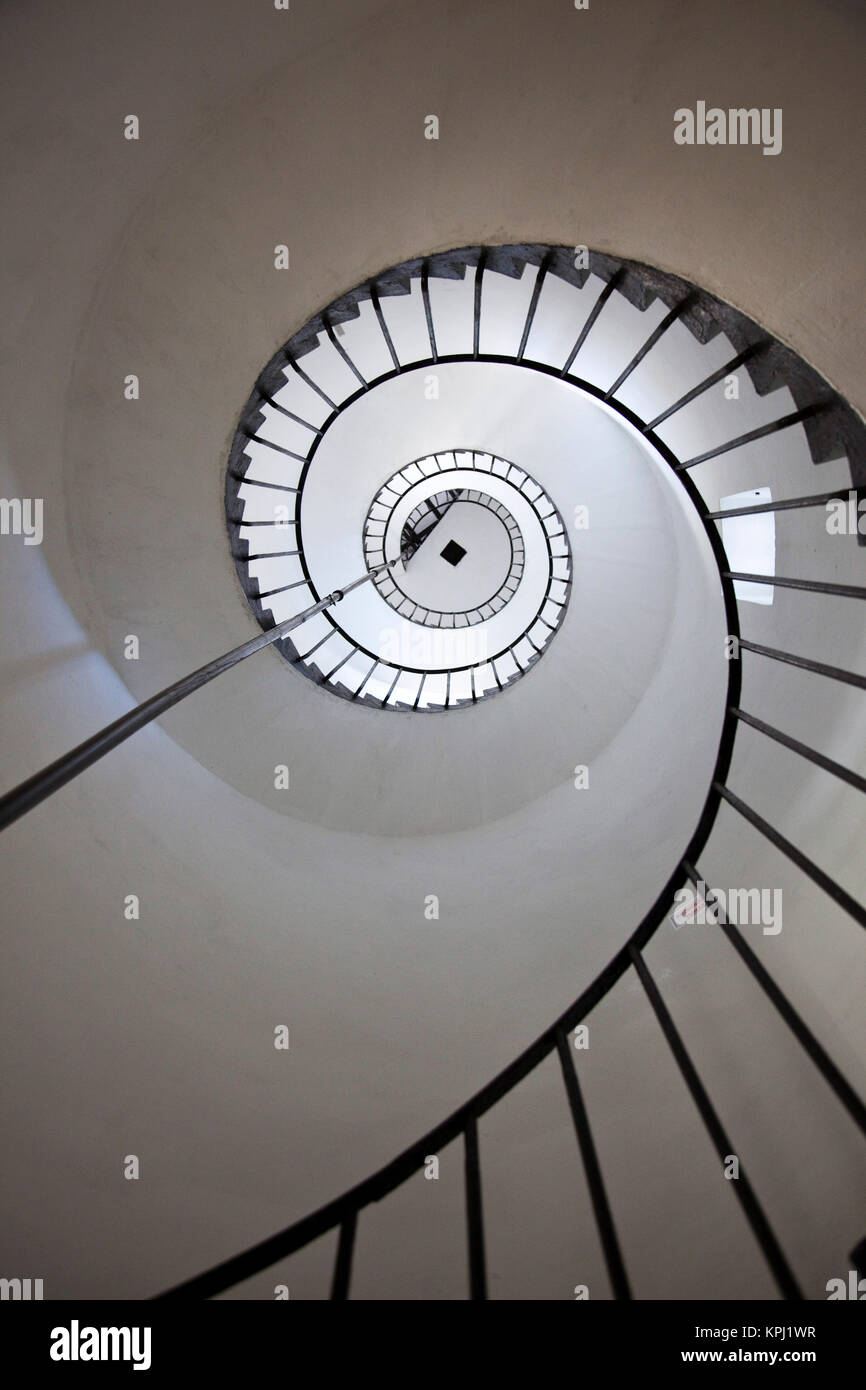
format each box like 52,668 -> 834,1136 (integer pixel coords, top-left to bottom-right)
202,246 -> 866,1298
